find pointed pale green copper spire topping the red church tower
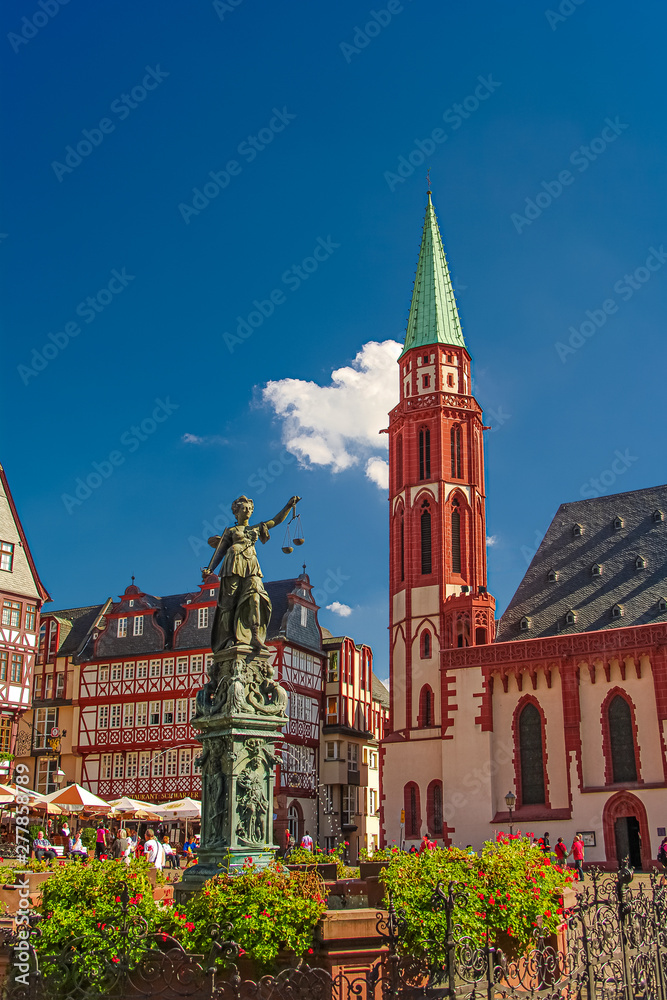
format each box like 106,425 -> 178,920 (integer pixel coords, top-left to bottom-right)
401,191 -> 466,357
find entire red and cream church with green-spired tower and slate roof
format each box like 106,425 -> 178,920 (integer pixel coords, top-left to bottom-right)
381,192 -> 667,868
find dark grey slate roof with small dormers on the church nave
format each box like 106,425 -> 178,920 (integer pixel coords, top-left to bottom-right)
496,486 -> 667,642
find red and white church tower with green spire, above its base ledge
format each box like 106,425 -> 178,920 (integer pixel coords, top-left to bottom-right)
389,191 -> 495,752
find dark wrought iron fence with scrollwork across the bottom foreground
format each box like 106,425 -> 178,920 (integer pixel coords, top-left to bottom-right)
4,867 -> 667,1000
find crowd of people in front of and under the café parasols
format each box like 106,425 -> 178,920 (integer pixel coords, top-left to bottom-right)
32,820 -> 199,869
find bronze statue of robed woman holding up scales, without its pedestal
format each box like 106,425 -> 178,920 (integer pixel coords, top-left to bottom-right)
202,496 -> 301,653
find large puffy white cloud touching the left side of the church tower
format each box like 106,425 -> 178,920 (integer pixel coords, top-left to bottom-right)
262,340 -> 402,489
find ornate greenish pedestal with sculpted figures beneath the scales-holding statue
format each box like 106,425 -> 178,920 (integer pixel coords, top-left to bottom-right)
175,645 -> 287,900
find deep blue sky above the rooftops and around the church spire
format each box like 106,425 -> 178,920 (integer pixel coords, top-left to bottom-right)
0,0 -> 667,677
